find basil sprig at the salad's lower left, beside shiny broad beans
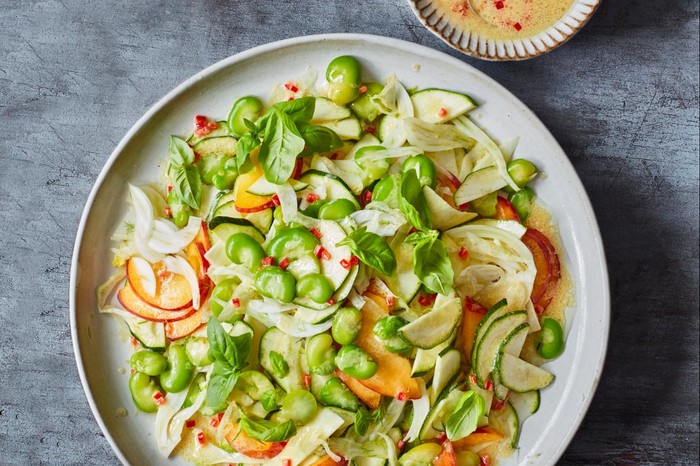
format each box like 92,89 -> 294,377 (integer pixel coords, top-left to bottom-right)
206,316 -> 252,409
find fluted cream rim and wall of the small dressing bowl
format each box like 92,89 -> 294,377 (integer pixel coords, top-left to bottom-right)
408,0 -> 601,61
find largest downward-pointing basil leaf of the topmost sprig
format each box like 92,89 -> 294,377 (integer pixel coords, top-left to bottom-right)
258,107 -> 304,184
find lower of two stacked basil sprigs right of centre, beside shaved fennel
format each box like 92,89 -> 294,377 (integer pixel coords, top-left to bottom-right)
406,230 -> 454,295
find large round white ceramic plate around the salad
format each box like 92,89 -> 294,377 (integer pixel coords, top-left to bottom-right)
70,34 -> 610,465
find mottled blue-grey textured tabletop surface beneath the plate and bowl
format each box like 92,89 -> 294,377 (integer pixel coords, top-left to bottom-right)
0,0 -> 698,465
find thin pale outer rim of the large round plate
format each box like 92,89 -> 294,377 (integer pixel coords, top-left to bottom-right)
69,33 -> 610,464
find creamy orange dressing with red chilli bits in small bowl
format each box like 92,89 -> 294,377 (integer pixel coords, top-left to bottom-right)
442,0 -> 573,40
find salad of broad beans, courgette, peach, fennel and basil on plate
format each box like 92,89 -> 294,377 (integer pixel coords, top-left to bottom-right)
97,56 -> 569,466
